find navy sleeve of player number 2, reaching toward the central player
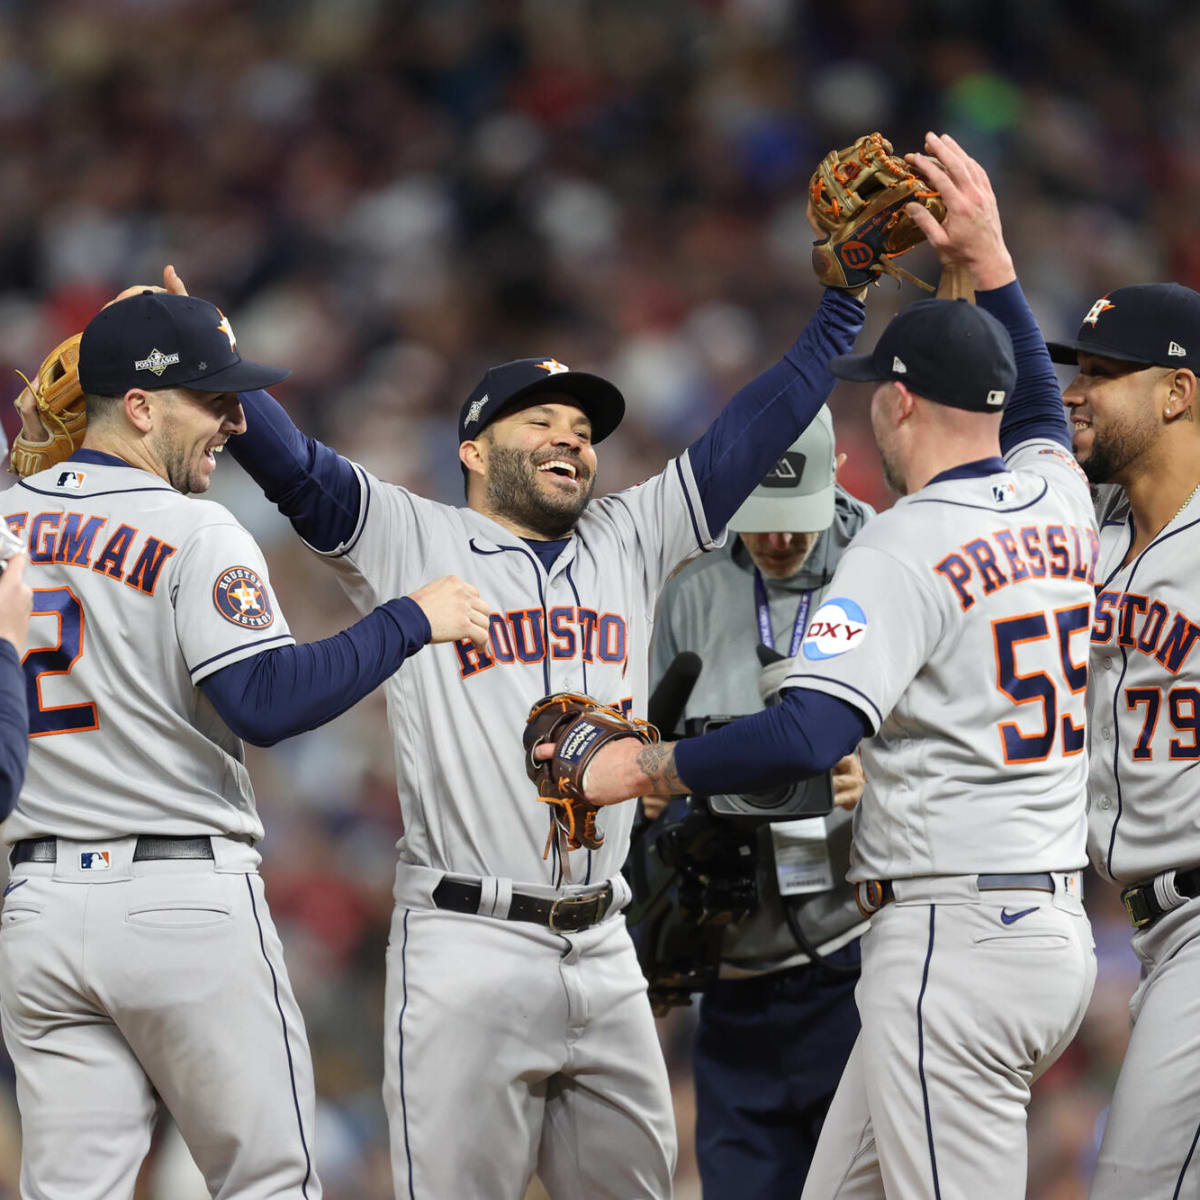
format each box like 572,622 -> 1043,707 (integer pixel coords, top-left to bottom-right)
200,596 -> 431,746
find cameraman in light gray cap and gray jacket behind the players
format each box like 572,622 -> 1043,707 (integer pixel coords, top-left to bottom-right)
647,408 -> 874,1200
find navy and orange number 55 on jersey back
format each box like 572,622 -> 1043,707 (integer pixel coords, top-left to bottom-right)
991,604 -> 1092,762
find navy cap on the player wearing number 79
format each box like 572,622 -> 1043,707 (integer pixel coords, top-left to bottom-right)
1046,283 -> 1200,374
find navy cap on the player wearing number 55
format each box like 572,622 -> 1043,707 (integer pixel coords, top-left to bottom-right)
829,300 -> 1016,413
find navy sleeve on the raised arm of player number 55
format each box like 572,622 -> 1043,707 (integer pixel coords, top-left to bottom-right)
976,280 -> 1070,454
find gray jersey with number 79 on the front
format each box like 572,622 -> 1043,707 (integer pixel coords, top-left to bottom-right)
1088,486 -> 1200,883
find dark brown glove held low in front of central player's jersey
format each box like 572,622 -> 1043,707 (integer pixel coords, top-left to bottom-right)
522,691 -> 659,857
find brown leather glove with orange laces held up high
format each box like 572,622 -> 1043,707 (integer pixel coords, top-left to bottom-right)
809,133 -> 946,292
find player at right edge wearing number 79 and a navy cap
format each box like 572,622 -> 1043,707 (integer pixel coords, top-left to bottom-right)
907,138 -> 1200,1200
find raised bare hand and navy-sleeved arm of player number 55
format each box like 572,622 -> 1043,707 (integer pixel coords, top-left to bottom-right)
906,133 -> 1070,454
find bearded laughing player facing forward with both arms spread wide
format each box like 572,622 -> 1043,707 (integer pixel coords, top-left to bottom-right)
223,283 -> 863,1200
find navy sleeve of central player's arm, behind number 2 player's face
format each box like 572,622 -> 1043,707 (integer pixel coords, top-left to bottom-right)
228,391 -> 361,551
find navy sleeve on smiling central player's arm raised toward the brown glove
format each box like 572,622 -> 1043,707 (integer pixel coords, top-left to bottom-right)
688,288 -> 865,536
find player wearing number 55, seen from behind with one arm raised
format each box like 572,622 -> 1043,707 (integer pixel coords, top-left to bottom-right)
566,144 -> 1099,1200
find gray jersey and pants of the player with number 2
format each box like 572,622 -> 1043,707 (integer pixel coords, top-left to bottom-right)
0,451 -> 322,1200
